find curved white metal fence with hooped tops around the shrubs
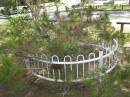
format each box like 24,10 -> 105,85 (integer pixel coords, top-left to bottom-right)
25,40 -> 118,82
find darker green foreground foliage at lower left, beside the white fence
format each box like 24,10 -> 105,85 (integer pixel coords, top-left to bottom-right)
0,55 -> 25,95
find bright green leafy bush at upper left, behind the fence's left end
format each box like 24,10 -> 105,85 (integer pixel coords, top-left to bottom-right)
0,17 -> 50,56
